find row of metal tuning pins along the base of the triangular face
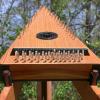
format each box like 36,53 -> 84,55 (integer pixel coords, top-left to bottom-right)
15,49 -> 84,63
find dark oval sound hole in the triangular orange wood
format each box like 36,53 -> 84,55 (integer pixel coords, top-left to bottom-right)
36,32 -> 58,40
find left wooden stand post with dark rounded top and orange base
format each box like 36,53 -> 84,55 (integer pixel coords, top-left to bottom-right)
0,70 -> 15,100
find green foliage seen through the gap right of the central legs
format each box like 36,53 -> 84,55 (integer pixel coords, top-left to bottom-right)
53,81 -> 81,100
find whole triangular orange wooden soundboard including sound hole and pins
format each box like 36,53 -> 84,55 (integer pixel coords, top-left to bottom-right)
0,7 -> 100,64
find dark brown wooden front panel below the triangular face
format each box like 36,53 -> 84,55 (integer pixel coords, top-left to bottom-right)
10,64 -> 92,80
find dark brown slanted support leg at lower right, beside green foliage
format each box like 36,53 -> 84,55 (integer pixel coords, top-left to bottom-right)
73,81 -> 100,100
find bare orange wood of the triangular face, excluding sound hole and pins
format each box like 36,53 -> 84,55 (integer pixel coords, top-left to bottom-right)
0,7 -> 100,64
